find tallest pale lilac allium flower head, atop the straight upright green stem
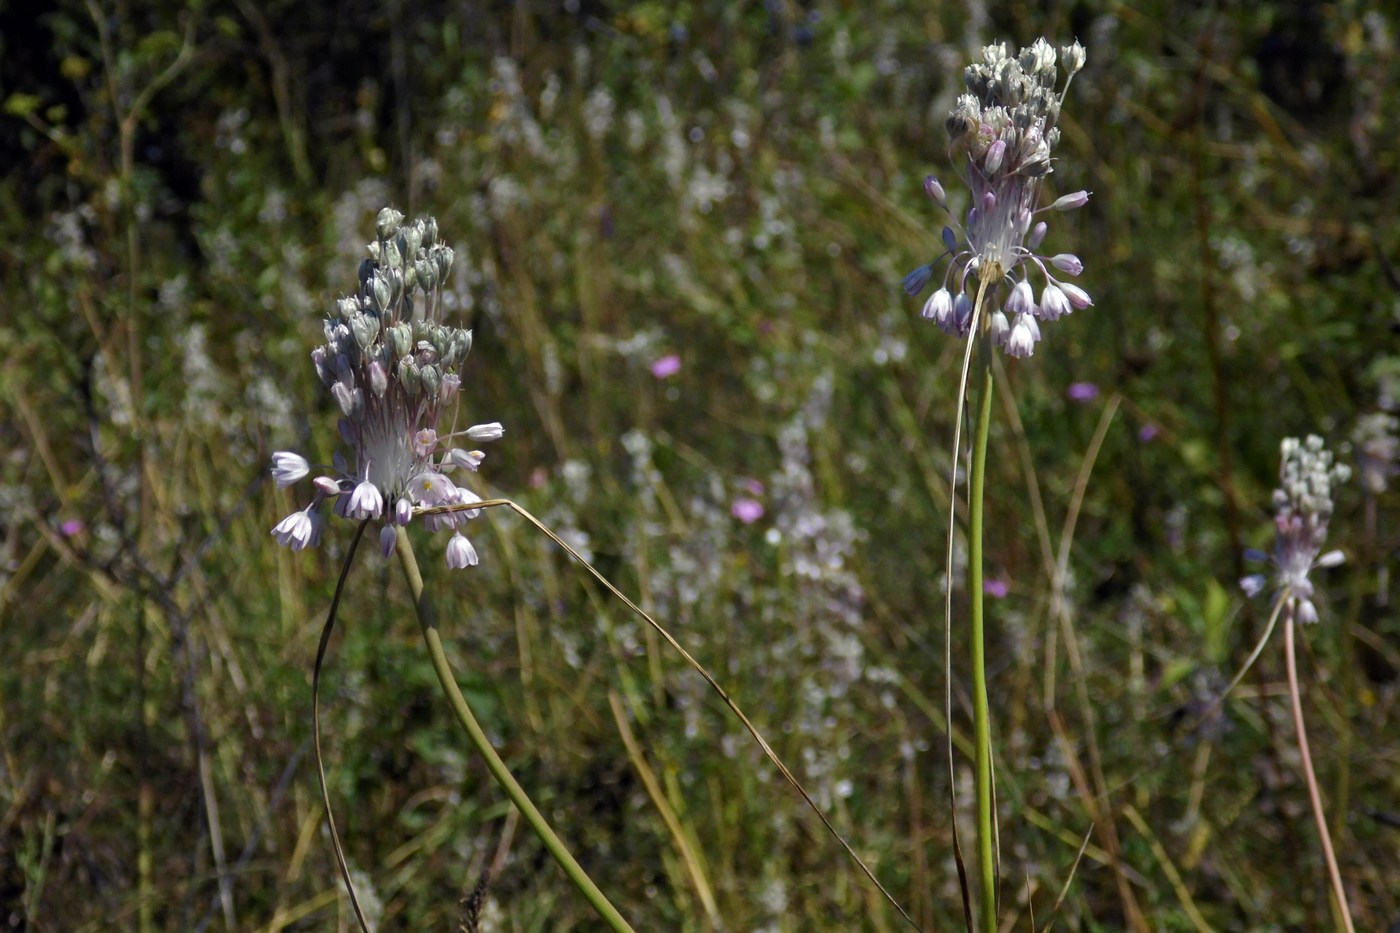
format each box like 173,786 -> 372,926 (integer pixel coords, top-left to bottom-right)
903,39 -> 1093,357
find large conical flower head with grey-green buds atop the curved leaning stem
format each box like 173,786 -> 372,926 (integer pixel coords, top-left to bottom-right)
272,207 -> 504,567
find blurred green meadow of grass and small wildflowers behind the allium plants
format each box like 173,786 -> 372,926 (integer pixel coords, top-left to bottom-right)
0,0 -> 1400,933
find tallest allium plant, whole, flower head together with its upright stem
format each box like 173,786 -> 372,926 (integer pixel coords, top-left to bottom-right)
903,39 -> 1093,933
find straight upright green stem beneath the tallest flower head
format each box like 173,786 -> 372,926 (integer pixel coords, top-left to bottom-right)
967,318 -> 997,933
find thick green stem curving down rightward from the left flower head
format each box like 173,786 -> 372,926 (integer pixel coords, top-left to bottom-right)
395,525 -> 634,933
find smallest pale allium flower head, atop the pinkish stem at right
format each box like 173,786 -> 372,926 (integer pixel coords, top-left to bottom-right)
1240,434 -> 1351,622
